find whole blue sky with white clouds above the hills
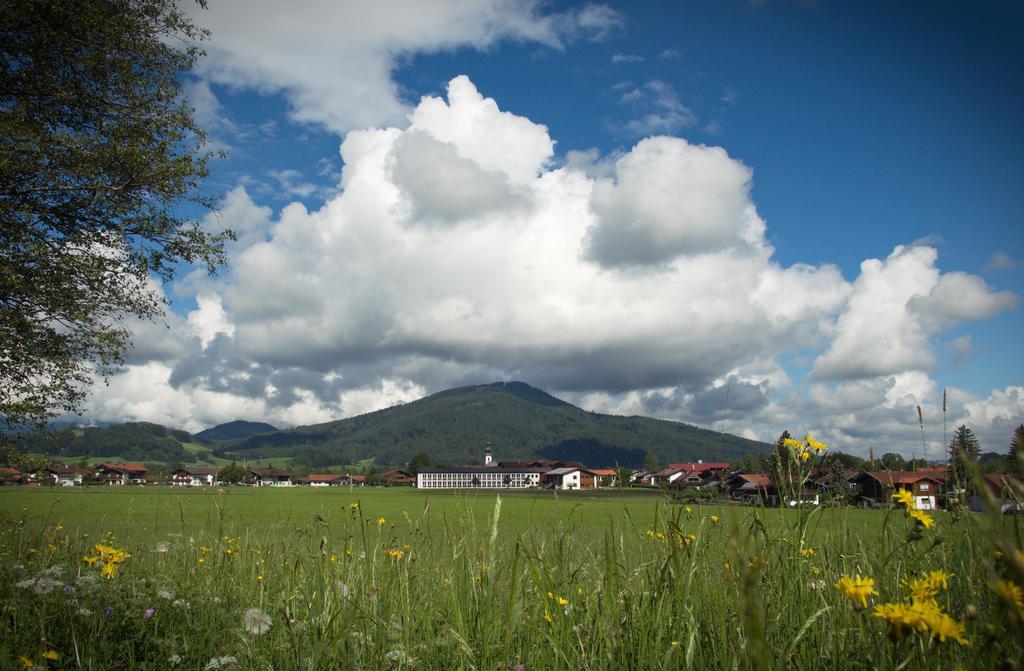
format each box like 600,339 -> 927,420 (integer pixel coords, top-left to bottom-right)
75,0 -> 1024,459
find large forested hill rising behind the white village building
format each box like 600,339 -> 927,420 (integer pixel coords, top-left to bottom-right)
214,382 -> 770,467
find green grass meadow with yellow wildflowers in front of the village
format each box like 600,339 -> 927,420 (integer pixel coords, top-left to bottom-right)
0,488 -> 1024,670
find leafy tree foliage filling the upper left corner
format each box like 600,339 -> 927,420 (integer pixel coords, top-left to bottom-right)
0,0 -> 230,429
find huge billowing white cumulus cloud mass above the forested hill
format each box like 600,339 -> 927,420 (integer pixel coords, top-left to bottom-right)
79,77 -> 1024,452
